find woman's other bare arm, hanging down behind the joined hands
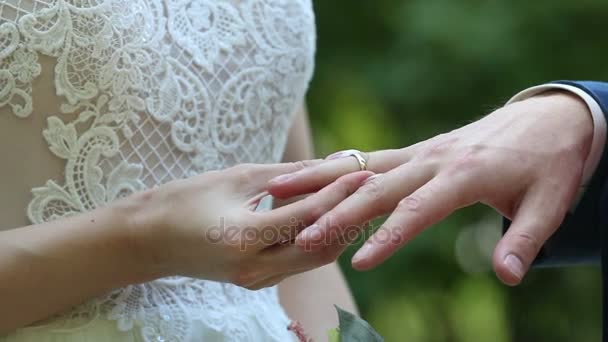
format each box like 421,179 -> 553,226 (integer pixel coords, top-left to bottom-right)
279,105 -> 357,341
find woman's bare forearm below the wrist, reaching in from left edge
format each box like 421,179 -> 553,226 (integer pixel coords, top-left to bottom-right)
0,201 -> 154,335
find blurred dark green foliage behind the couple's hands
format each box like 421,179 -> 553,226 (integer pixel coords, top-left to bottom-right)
308,0 -> 608,342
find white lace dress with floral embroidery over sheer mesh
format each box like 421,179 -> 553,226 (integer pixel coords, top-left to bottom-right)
0,0 -> 315,341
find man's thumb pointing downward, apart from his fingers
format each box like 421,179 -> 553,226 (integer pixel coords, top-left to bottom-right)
493,184 -> 572,286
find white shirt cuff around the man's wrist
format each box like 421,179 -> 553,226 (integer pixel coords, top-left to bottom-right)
507,83 -> 606,187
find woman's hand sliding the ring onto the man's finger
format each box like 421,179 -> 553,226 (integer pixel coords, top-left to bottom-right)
125,162 -> 372,289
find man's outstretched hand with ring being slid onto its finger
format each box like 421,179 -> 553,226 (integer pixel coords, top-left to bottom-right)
270,92 -> 593,285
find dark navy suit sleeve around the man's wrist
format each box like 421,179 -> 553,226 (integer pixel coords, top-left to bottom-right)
504,81 -> 608,267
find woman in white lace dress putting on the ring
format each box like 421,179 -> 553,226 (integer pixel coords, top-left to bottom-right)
0,0 -> 369,342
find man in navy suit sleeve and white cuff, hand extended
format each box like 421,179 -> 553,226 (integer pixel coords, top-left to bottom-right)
270,81 -> 608,342
